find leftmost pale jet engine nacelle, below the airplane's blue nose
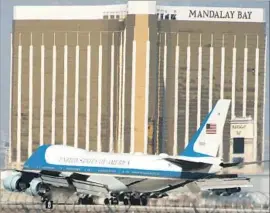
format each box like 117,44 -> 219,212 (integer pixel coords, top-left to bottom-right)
3,172 -> 24,192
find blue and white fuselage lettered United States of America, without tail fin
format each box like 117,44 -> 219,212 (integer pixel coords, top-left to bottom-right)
24,146 -> 220,180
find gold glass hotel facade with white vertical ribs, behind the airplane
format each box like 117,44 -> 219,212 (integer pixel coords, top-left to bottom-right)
11,3 -> 265,170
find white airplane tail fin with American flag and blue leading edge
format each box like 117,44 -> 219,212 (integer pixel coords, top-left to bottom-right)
180,99 -> 231,157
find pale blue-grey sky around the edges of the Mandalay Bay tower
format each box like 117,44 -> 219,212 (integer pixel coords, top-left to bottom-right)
0,0 -> 269,159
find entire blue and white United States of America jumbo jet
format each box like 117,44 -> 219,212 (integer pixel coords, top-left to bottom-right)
0,99 -> 266,205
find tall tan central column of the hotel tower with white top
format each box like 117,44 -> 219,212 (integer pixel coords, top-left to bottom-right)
126,1 -> 157,153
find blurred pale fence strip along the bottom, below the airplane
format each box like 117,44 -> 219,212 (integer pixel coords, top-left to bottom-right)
0,191 -> 270,213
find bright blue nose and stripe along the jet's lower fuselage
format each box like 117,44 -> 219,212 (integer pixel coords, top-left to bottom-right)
24,145 -> 209,179
